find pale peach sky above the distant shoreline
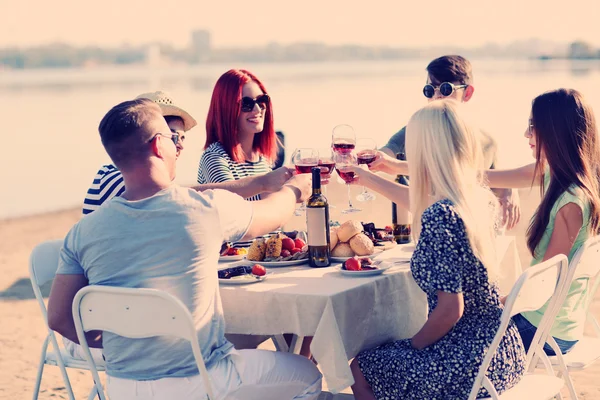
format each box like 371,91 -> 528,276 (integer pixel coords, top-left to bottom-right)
0,0 -> 600,47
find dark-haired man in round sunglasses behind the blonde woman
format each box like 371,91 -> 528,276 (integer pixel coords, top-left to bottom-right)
382,55 -> 521,229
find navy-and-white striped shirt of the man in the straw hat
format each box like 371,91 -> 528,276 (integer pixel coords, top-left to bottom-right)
83,164 -> 125,215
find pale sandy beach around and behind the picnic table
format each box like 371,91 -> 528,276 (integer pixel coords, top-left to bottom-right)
0,182 -> 600,400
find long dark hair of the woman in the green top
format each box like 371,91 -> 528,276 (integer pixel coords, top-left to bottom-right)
527,89 -> 600,257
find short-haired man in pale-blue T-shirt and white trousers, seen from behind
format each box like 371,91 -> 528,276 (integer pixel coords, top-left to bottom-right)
48,99 -> 321,400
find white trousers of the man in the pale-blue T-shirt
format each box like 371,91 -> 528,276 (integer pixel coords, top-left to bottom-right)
106,350 -> 321,400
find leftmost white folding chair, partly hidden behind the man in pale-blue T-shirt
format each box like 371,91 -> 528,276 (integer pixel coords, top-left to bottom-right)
29,240 -> 104,400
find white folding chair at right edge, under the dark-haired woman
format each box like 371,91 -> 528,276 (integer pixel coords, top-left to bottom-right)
548,236 -> 600,400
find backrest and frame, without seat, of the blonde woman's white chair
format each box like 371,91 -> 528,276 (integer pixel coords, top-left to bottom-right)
469,254 -> 568,400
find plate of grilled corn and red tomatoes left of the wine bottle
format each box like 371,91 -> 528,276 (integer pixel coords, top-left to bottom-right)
246,232 -> 308,267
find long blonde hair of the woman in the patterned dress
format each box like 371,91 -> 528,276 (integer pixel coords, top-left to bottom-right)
406,99 -> 497,279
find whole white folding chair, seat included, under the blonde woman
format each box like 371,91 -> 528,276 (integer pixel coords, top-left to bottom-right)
469,254 -> 568,400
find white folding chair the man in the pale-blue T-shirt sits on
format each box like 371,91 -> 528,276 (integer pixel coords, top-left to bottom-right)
72,285 -> 215,400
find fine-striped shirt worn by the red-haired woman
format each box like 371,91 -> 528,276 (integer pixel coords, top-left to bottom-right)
198,142 -> 273,247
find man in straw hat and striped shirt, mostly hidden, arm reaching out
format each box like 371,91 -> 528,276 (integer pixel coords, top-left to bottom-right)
83,91 -> 292,215
